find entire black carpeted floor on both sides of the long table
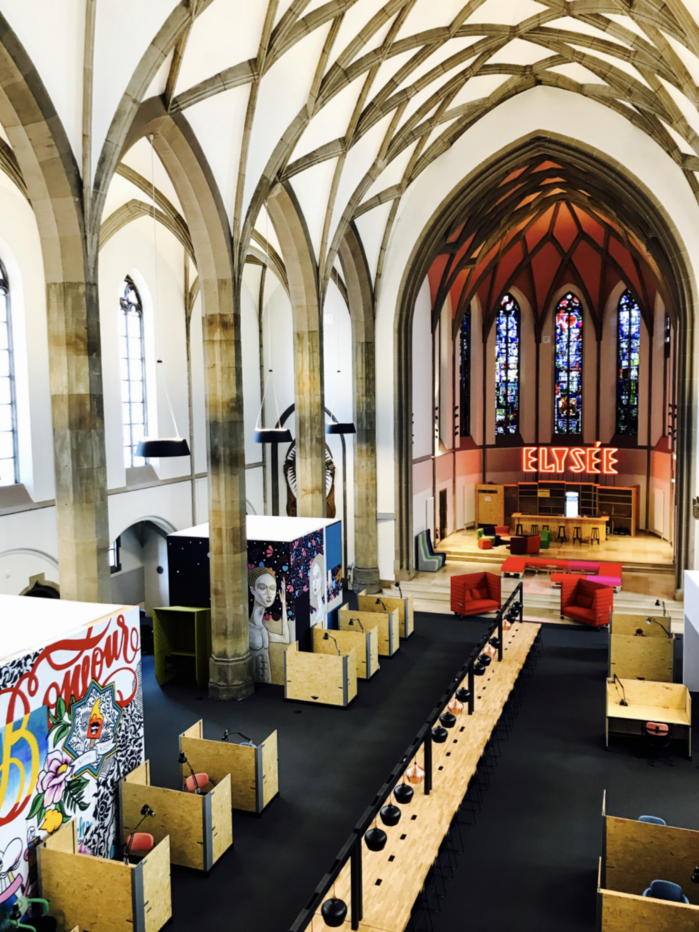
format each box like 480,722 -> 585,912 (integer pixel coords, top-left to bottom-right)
144,614 -> 699,932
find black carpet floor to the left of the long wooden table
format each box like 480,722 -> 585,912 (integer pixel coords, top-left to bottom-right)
144,613 -> 487,932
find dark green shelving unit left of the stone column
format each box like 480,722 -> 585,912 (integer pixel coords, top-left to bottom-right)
153,605 -> 211,689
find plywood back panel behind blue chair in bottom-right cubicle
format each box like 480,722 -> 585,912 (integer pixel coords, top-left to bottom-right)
605,816 -> 699,904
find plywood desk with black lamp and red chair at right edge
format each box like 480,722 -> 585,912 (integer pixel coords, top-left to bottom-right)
605,680 -> 692,760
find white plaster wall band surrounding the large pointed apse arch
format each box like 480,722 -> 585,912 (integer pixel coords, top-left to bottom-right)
376,87 -> 699,579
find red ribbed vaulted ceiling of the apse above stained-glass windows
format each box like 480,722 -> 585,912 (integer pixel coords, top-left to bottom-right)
429,158 -> 672,336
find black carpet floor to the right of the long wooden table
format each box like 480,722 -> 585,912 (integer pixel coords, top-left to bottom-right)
433,625 -> 699,932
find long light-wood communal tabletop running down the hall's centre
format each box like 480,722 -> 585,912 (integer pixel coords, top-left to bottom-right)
310,624 -> 540,932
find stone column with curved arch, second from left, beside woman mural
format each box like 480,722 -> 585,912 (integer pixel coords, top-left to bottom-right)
124,98 -> 254,699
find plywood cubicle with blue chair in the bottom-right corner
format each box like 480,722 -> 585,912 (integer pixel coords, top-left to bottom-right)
597,796 -> 699,932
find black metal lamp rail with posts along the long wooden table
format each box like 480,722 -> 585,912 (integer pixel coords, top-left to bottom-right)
290,582 -> 524,932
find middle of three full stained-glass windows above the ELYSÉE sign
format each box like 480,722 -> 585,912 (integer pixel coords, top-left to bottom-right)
553,291 -> 582,434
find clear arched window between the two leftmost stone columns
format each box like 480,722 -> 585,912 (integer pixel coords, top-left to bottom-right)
119,276 -> 148,469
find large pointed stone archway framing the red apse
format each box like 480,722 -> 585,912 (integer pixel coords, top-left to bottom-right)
394,133 -> 697,589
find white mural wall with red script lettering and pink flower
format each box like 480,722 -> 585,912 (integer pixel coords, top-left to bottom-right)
0,608 -> 144,909
